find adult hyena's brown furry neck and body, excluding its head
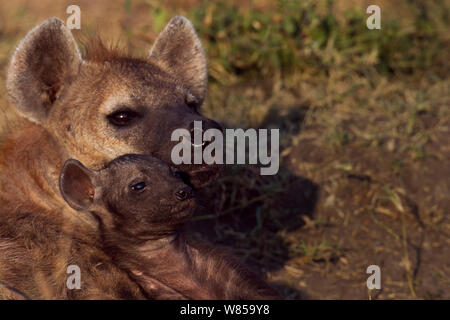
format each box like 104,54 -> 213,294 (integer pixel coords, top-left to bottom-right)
0,126 -> 143,299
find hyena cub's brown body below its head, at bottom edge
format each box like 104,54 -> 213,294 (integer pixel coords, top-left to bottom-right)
115,235 -> 277,300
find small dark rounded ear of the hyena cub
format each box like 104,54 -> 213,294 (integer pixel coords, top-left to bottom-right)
59,159 -> 97,210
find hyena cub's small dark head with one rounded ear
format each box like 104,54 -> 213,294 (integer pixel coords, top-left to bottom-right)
59,154 -> 195,242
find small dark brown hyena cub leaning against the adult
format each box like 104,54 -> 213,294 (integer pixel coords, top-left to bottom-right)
59,155 -> 278,299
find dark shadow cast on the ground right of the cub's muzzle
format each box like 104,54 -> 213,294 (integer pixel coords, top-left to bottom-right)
188,107 -> 319,299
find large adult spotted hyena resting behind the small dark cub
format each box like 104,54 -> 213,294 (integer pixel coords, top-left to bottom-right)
0,17 -> 219,298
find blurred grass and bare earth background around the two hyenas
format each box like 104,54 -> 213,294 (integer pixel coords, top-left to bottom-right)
0,0 -> 450,299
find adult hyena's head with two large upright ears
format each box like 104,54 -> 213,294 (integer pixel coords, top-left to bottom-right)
7,17 -> 220,187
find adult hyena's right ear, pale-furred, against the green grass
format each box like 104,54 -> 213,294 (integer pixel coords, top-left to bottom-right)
150,16 -> 208,104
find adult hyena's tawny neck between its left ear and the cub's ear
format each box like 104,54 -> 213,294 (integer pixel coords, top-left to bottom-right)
0,123 -> 94,224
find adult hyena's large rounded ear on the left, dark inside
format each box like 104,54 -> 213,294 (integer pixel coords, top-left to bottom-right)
6,18 -> 82,123
